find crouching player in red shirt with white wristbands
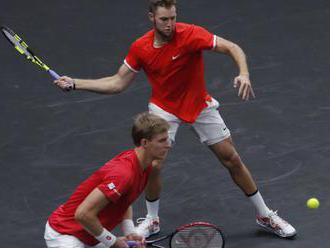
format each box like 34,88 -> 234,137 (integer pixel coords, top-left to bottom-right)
45,113 -> 170,248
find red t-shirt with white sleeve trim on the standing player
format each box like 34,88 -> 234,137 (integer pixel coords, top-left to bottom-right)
124,23 -> 216,123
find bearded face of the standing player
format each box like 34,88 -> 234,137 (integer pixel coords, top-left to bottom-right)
149,6 -> 176,39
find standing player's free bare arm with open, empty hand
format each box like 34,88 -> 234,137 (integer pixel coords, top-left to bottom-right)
214,36 -> 255,100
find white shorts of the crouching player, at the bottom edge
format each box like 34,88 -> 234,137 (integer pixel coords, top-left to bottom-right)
44,222 -> 107,248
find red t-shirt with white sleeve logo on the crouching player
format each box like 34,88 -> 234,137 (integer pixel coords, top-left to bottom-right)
48,150 -> 152,246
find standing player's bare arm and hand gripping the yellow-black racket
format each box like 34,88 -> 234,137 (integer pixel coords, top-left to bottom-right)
54,64 -> 136,94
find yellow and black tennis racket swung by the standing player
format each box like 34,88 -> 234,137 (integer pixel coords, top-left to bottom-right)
1,26 -> 60,79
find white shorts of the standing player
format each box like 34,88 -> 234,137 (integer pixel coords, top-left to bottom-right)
148,98 -> 230,146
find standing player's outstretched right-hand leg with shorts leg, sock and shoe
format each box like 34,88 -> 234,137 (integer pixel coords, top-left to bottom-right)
193,99 -> 296,237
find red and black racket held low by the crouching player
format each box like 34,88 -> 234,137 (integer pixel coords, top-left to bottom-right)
129,222 -> 225,248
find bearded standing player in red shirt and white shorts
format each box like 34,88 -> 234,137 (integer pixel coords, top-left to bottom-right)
55,0 -> 296,237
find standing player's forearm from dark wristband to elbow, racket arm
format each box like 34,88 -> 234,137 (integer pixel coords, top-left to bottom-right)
74,75 -> 124,94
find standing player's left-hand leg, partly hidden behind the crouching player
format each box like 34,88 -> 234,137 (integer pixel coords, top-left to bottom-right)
136,103 -> 181,238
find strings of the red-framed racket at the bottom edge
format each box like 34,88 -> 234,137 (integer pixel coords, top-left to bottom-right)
171,226 -> 223,248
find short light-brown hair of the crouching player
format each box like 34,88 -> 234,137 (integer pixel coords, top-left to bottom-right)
132,112 -> 170,146
